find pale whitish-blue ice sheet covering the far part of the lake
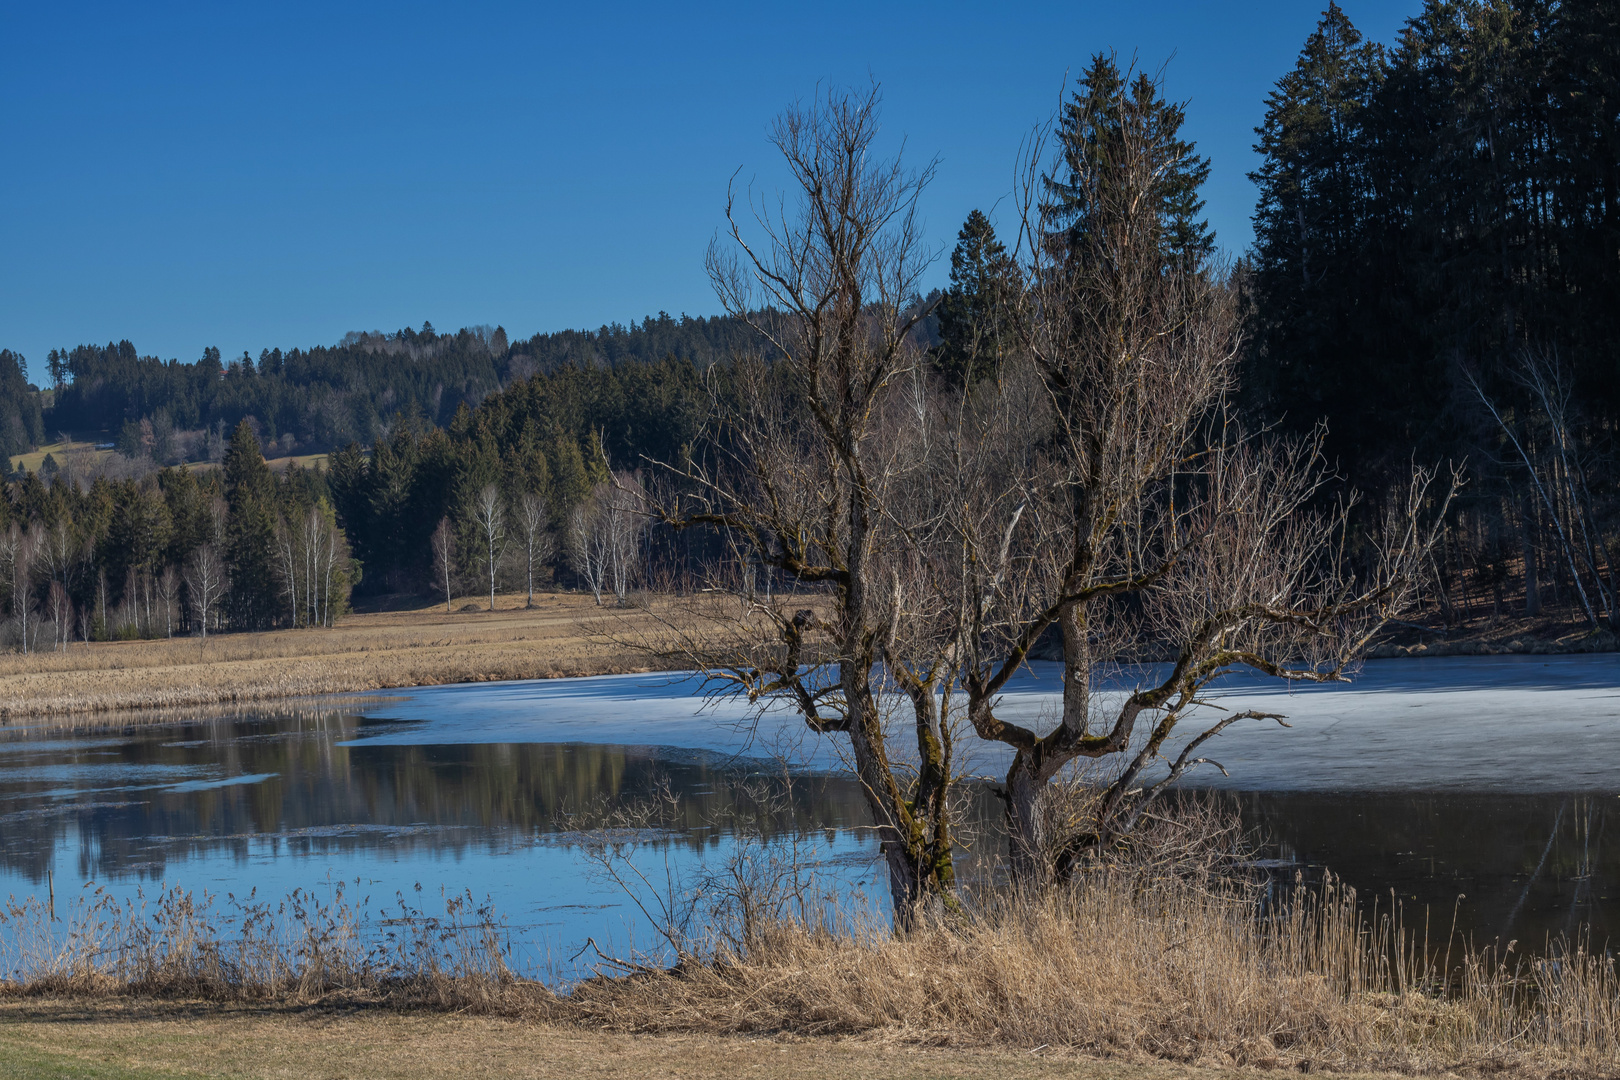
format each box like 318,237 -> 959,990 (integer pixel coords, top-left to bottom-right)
356,654 -> 1620,792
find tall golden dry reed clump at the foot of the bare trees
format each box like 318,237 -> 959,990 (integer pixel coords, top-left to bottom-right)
549,874 -> 1620,1072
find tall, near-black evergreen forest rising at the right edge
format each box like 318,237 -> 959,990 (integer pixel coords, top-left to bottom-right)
1239,0 -> 1620,623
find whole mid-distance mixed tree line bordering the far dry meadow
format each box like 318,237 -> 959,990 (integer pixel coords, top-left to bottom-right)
0,335 -> 774,649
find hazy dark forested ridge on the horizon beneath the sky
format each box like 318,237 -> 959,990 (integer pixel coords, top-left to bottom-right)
25,313 -> 771,465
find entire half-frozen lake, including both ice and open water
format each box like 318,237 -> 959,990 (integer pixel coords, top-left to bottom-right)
0,656 -> 1620,970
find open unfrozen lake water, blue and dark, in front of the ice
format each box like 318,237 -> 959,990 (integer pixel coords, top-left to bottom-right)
0,696 -> 1620,949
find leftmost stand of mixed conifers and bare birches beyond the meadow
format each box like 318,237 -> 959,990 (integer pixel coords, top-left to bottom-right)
0,424 -> 360,653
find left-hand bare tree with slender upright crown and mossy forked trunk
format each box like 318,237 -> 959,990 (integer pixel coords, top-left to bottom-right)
641,87 -> 959,923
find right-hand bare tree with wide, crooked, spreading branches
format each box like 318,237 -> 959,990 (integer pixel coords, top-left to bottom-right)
939,65 -> 1448,881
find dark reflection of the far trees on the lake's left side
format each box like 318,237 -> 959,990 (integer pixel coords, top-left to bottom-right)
0,711 -> 887,884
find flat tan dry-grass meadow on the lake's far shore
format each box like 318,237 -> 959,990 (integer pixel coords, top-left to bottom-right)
0,593 -> 677,722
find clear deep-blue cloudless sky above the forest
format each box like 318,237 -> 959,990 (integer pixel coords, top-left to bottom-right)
0,0 -> 1418,388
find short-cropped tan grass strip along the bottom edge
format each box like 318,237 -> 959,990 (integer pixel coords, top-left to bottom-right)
0,999 -> 1406,1080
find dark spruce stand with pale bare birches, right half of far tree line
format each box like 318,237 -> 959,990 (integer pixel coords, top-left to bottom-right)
327,356 -> 709,599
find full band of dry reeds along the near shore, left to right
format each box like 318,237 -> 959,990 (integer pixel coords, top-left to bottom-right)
0,878 -> 1620,1077
